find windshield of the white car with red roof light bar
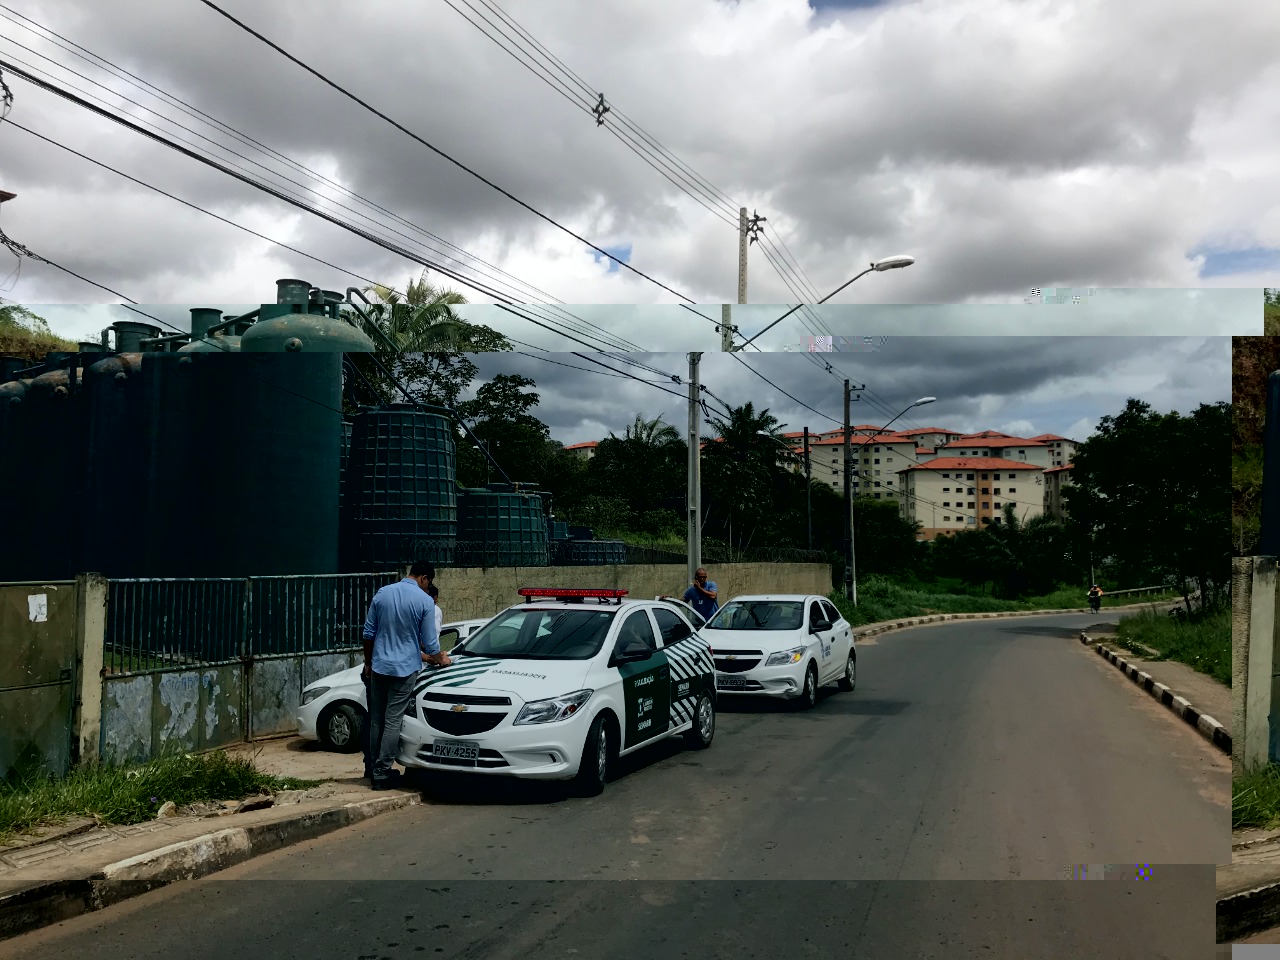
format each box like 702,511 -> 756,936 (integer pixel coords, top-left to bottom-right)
463,607 -> 617,660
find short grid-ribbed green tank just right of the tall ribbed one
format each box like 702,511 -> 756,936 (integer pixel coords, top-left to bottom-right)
458,490 -> 549,567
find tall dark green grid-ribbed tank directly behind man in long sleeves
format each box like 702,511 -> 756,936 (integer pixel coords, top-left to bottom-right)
346,403 -> 458,571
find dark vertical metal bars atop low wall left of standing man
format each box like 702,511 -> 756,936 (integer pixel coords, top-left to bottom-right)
104,571 -> 401,673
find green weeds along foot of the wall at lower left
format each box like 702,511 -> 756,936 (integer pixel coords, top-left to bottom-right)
0,750 -> 319,844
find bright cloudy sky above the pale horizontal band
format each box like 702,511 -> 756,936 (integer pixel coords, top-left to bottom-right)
0,0 -> 1280,327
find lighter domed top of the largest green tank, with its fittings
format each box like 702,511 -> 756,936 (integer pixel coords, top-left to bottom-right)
241,280 -> 374,353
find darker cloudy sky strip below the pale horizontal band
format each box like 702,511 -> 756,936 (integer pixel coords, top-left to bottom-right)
448,337 -> 1231,444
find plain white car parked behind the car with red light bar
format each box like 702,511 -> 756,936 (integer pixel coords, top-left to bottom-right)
701,594 -> 858,709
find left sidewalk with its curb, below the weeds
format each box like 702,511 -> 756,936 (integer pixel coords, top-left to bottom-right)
0,737 -> 409,940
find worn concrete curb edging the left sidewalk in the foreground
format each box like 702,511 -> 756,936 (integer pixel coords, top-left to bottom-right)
0,794 -> 419,941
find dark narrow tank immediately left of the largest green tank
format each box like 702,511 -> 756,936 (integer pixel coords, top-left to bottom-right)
83,353 -> 147,577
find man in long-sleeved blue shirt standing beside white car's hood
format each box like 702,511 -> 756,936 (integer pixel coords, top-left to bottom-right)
364,562 -> 451,790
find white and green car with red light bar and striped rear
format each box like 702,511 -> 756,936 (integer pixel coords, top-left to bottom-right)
397,588 -> 716,795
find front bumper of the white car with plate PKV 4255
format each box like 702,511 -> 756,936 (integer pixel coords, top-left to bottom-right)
397,712 -> 591,780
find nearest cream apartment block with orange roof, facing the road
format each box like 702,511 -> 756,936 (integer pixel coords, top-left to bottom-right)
899,457 -> 1044,540
